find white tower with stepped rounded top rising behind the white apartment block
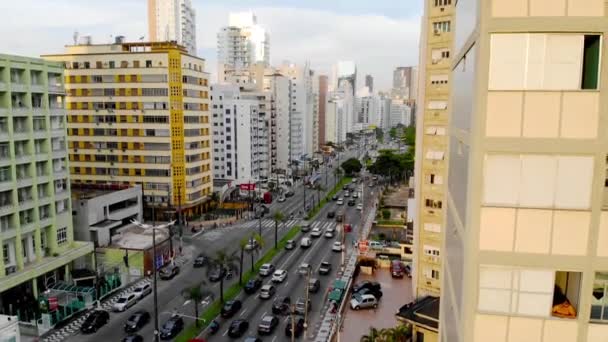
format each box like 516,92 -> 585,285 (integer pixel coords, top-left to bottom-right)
217,12 -> 270,82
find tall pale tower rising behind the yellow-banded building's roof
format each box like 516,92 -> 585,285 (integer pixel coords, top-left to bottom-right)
148,0 -> 197,56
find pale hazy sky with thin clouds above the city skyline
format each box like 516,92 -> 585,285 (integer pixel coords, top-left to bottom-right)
0,0 -> 422,90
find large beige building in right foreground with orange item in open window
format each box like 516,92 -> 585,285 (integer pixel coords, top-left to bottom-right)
442,0 -> 608,342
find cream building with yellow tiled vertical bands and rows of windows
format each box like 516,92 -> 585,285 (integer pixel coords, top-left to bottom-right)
44,40 -> 213,218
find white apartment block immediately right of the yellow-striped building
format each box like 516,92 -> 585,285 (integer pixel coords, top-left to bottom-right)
211,85 -> 270,184
